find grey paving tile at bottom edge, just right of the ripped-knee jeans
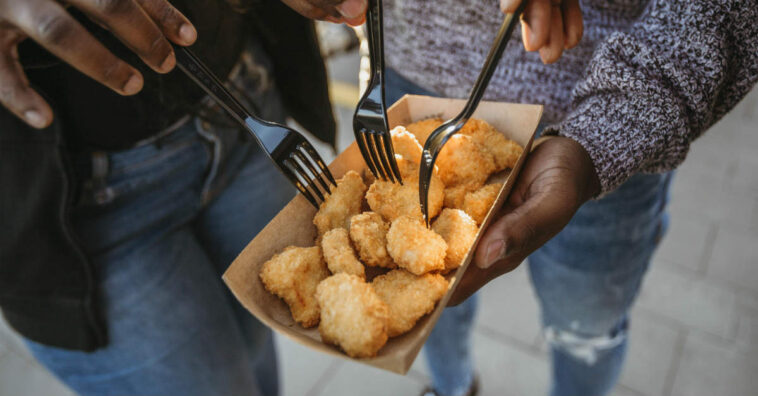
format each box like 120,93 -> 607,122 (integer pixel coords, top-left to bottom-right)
620,315 -> 679,396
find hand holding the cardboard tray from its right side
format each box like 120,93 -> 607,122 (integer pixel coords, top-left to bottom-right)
449,137 -> 600,305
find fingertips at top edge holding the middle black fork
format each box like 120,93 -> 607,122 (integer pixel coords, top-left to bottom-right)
282,0 -> 368,26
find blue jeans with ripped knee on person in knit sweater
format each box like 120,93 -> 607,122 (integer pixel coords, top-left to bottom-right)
387,71 -> 672,396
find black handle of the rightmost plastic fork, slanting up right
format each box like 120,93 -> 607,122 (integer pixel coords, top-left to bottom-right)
457,0 -> 527,119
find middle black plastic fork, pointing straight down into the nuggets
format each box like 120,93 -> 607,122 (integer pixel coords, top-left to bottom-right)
353,0 -> 403,183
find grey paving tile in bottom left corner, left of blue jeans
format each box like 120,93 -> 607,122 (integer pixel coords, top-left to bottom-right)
0,353 -> 74,396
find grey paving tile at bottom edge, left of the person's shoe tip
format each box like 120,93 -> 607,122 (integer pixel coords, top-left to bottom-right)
313,362 -> 424,396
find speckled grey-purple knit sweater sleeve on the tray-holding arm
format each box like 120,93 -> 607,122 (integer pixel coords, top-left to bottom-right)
545,0 -> 758,194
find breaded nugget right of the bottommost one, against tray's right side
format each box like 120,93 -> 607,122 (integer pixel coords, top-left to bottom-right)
371,269 -> 448,337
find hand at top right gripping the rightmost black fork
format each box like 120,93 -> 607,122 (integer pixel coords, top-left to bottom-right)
500,0 -> 584,63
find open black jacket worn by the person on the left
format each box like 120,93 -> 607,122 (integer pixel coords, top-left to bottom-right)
0,0 -> 335,351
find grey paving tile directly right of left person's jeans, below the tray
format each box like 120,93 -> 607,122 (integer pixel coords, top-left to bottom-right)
276,335 -> 337,396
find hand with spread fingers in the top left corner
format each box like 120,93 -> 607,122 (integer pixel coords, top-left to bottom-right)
0,0 -> 197,128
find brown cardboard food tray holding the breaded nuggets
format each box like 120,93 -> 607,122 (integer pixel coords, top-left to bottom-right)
223,95 -> 542,374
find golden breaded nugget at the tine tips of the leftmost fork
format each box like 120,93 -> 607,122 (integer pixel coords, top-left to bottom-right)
313,170 -> 366,236
